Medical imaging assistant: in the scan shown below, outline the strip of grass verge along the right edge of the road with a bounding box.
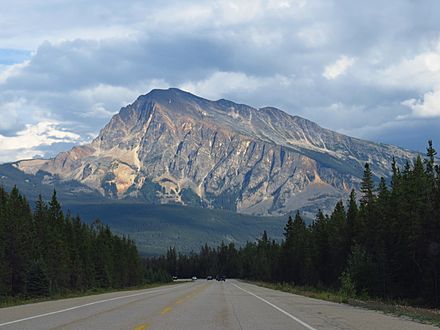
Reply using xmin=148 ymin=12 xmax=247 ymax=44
xmin=248 ymin=281 xmax=440 ymax=327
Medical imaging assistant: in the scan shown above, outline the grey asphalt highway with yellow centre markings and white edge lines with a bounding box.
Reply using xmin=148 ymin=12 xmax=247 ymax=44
xmin=0 ymin=280 xmax=438 ymax=330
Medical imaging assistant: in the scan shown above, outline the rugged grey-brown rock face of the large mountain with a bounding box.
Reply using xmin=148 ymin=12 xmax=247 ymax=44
xmin=14 ymin=89 xmax=415 ymax=215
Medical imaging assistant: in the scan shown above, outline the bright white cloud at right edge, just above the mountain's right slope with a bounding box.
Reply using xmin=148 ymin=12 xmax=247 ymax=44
xmin=400 ymin=88 xmax=440 ymax=118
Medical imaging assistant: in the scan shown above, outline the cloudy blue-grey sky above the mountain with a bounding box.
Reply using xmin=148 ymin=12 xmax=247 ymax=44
xmin=0 ymin=0 xmax=440 ymax=163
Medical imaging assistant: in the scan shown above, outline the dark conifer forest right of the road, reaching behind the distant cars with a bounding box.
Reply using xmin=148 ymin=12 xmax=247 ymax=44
xmin=146 ymin=141 xmax=440 ymax=307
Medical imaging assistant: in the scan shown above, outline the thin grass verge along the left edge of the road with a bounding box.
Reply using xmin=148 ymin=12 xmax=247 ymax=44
xmin=0 ymin=282 xmax=180 ymax=308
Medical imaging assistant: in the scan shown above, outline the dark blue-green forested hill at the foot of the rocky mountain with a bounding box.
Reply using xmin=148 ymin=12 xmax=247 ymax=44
xmin=64 ymin=201 xmax=287 ymax=255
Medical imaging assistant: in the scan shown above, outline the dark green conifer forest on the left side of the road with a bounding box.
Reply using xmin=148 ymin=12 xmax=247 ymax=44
xmin=0 ymin=188 xmax=143 ymax=300
